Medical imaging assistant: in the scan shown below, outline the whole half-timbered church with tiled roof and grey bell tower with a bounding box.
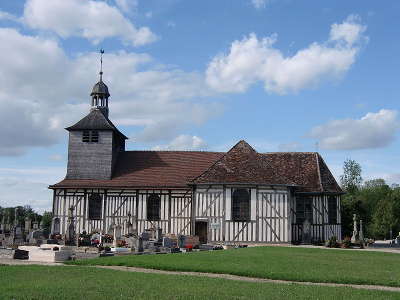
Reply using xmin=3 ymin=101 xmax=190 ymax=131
xmin=49 ymin=73 xmax=343 ymax=243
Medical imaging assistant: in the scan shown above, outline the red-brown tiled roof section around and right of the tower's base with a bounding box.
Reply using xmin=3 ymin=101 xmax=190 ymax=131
xmin=51 ymin=151 xmax=224 ymax=188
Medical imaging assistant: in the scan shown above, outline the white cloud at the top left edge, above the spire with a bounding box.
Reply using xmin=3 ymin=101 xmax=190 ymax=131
xmin=23 ymin=0 xmax=156 ymax=46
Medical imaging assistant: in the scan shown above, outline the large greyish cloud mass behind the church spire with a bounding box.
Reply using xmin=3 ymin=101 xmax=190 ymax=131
xmin=0 ymin=28 xmax=220 ymax=155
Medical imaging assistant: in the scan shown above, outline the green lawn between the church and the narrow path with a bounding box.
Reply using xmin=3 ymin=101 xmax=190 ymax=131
xmin=73 ymin=247 xmax=400 ymax=287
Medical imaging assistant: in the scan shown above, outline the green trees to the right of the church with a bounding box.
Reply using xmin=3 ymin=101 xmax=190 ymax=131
xmin=340 ymin=159 xmax=400 ymax=239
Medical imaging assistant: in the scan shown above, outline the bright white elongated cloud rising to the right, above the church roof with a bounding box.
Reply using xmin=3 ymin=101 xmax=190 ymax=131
xmin=206 ymin=16 xmax=366 ymax=94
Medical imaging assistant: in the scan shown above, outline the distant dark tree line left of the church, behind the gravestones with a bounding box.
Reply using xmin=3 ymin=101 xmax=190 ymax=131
xmin=0 ymin=205 xmax=52 ymax=231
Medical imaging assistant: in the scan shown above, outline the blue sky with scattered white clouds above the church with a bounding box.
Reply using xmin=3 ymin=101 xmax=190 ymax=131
xmin=0 ymin=0 xmax=400 ymax=210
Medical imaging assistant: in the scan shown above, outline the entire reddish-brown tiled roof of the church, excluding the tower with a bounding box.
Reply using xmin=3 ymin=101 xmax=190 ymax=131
xmin=50 ymin=141 xmax=342 ymax=193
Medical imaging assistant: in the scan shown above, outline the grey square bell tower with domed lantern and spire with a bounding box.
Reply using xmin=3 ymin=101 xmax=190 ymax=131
xmin=65 ymin=50 xmax=127 ymax=180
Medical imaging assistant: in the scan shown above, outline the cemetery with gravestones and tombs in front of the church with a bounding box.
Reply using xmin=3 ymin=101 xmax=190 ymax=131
xmin=0 ymin=209 xmax=230 ymax=262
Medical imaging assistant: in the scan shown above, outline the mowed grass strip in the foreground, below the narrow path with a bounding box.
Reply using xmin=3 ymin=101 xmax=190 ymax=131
xmin=0 ymin=266 xmax=400 ymax=300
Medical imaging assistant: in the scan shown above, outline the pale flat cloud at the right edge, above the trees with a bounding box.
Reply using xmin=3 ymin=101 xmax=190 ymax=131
xmin=309 ymin=109 xmax=400 ymax=150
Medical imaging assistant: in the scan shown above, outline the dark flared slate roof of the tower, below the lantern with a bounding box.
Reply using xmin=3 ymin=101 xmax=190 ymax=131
xmin=65 ymin=109 xmax=127 ymax=139
